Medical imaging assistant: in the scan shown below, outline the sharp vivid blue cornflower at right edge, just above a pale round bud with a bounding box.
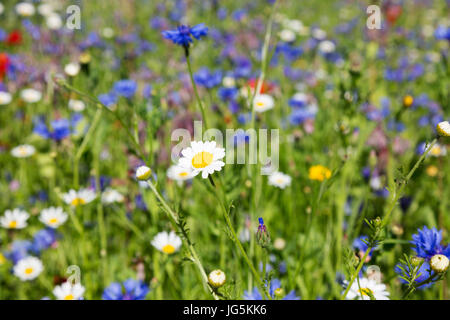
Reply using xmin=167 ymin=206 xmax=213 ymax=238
xmin=411 ymin=226 xmax=450 ymax=259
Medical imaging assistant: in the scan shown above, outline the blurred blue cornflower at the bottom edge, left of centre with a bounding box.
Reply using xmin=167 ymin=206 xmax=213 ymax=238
xmin=102 ymin=279 xmax=150 ymax=300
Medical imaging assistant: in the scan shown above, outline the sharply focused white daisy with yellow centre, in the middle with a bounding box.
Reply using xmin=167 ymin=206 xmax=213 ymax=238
xmin=178 ymin=141 xmax=225 ymax=179
